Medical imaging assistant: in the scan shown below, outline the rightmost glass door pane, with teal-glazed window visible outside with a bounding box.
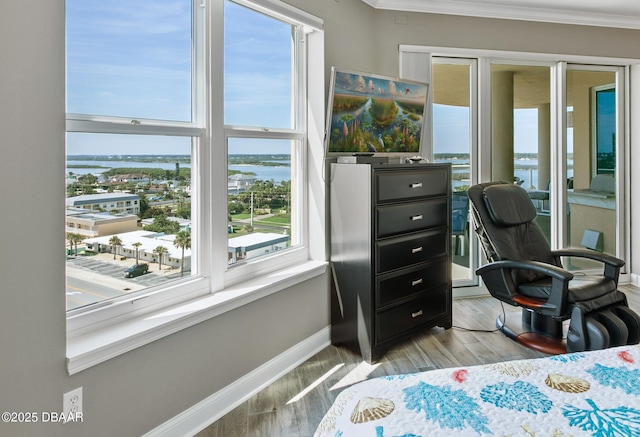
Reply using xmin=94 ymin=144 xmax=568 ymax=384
xmin=565 ymin=66 xmax=621 ymax=270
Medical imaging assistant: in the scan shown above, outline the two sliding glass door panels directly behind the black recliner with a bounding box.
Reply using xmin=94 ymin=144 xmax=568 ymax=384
xmin=488 ymin=62 xmax=624 ymax=270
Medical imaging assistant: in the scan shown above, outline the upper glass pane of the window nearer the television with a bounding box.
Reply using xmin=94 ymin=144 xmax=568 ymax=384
xmin=224 ymin=1 xmax=295 ymax=129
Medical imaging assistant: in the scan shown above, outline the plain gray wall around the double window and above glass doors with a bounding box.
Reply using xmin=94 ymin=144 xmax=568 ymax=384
xmin=0 ymin=0 xmax=640 ymax=437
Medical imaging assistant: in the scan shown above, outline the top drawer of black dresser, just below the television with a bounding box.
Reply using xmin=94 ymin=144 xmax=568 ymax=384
xmin=375 ymin=168 xmax=450 ymax=203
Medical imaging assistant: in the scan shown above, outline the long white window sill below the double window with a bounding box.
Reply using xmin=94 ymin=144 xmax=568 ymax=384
xmin=67 ymin=261 xmax=327 ymax=375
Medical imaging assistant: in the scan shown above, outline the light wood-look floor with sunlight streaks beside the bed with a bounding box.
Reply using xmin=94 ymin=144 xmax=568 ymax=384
xmin=196 ymin=285 xmax=640 ymax=437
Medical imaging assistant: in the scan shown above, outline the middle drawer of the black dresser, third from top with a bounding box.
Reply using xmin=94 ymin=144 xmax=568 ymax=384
xmin=375 ymin=229 xmax=449 ymax=273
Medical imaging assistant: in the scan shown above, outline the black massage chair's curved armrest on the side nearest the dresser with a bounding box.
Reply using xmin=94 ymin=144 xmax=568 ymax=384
xmin=476 ymin=260 xmax=573 ymax=317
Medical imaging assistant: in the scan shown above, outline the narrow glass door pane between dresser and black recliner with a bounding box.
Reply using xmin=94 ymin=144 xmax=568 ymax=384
xmin=431 ymin=58 xmax=475 ymax=285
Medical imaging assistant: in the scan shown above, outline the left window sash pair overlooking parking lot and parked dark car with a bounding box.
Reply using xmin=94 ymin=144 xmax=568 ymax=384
xmin=66 ymin=0 xmax=202 ymax=312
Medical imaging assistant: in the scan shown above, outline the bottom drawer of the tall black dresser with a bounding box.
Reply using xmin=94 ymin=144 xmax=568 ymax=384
xmin=376 ymin=288 xmax=449 ymax=343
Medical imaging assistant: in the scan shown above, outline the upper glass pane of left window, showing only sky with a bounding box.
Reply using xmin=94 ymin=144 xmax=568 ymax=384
xmin=66 ymin=0 xmax=192 ymax=121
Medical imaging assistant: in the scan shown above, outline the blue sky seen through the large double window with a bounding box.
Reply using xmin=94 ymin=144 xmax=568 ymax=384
xmin=66 ymin=0 xmax=292 ymax=155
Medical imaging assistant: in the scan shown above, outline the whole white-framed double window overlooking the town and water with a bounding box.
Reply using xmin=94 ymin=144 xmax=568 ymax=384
xmin=65 ymin=0 xmax=321 ymax=333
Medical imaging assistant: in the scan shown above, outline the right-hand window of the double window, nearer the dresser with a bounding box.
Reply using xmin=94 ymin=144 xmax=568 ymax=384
xmin=224 ymin=1 xmax=305 ymax=266
